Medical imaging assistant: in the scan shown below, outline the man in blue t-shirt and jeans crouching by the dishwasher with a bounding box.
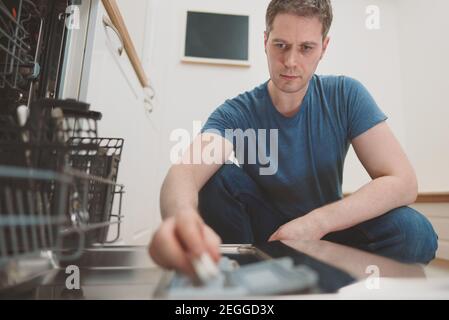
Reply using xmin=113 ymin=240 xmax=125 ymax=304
xmin=150 ymin=0 xmax=437 ymax=274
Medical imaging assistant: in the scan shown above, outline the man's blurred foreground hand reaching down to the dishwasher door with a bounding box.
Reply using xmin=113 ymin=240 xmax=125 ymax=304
xmin=149 ymin=212 xmax=221 ymax=277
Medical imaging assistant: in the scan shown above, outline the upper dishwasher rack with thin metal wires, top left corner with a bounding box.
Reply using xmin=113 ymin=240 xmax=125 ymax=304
xmin=0 ymin=0 xmax=74 ymax=114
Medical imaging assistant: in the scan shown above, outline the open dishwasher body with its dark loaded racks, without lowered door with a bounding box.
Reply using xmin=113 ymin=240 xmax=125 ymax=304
xmin=0 ymin=0 xmax=124 ymax=298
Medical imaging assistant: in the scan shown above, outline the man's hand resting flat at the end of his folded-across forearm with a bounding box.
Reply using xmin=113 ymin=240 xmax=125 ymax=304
xmin=268 ymin=212 xmax=327 ymax=241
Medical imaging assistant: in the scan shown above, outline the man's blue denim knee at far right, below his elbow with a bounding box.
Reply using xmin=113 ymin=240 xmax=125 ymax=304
xmin=360 ymin=207 xmax=438 ymax=263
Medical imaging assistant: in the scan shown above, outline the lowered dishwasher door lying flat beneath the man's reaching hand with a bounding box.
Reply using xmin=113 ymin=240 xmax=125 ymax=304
xmin=10 ymin=242 xmax=356 ymax=300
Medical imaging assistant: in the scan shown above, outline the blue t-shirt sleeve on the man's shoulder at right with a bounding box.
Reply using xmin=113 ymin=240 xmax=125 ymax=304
xmin=344 ymin=77 xmax=388 ymax=140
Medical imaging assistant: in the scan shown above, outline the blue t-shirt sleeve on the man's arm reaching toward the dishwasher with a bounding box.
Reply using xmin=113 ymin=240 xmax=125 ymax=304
xmin=201 ymin=100 xmax=241 ymax=143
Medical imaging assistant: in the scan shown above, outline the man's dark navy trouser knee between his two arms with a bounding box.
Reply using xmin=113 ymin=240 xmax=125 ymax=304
xmin=199 ymin=165 xmax=286 ymax=243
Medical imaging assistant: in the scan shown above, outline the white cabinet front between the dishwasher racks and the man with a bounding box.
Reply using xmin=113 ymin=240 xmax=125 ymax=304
xmin=74 ymin=0 xmax=160 ymax=244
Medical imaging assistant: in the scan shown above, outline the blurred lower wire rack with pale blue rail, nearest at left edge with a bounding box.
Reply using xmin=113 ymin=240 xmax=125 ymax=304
xmin=0 ymin=166 xmax=70 ymax=259
